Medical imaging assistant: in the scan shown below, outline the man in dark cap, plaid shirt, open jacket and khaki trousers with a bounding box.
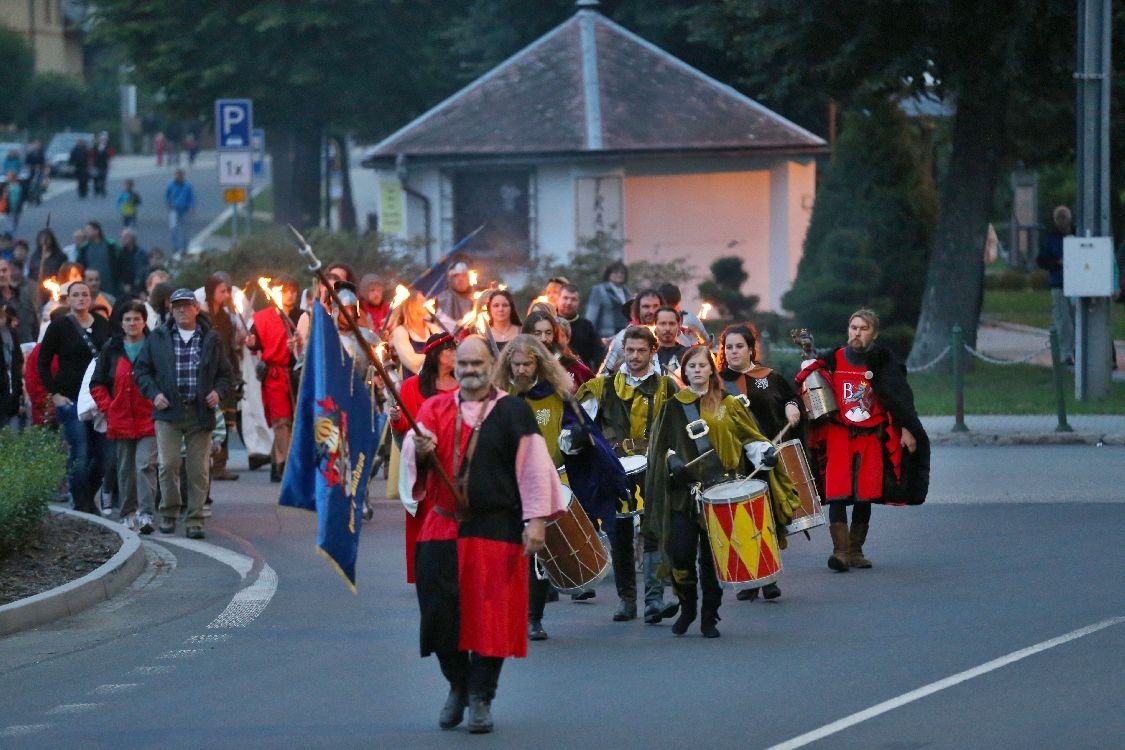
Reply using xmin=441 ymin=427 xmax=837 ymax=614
xmin=134 ymin=289 xmax=233 ymax=539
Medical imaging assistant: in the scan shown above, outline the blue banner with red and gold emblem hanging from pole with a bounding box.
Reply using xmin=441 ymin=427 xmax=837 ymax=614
xmin=280 ymin=305 xmax=386 ymax=591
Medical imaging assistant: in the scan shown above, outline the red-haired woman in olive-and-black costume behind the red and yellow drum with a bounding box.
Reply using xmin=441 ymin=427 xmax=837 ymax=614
xmin=645 ymin=345 xmax=798 ymax=638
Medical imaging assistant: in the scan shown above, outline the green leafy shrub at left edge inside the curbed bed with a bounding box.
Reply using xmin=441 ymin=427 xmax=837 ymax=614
xmin=0 ymin=427 xmax=66 ymax=558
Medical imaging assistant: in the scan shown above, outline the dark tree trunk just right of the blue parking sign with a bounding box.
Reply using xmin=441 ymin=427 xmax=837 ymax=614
xmin=271 ymin=124 xmax=321 ymax=229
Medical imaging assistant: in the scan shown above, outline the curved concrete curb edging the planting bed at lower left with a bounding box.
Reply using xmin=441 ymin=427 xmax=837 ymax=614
xmin=0 ymin=506 xmax=147 ymax=636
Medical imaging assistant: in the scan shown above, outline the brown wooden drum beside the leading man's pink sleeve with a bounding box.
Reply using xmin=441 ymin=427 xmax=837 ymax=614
xmin=536 ymin=485 xmax=610 ymax=594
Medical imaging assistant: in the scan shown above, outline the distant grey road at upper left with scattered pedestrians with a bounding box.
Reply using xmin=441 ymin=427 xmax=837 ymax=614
xmin=19 ymin=152 xmax=226 ymax=263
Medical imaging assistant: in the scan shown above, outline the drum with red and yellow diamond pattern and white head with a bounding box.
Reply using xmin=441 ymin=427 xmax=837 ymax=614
xmin=702 ymin=479 xmax=781 ymax=589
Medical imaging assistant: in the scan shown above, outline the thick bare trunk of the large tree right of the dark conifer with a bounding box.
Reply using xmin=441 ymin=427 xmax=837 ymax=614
xmin=909 ymin=85 xmax=1006 ymax=369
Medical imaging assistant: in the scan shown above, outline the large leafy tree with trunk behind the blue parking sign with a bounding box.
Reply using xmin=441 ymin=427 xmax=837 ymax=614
xmin=96 ymin=0 xmax=457 ymax=227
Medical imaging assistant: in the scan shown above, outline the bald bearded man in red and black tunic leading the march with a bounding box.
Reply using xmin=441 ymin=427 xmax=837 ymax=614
xmin=403 ymin=336 xmax=566 ymax=733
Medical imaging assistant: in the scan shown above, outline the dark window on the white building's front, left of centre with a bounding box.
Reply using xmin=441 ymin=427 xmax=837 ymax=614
xmin=452 ymin=170 xmax=534 ymax=261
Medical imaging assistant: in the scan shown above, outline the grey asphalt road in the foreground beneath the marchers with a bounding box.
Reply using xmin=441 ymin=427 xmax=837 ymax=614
xmin=0 ymin=446 xmax=1125 ymax=750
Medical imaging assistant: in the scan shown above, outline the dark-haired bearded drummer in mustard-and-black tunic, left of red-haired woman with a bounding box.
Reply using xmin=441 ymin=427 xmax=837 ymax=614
xmin=576 ymin=326 xmax=680 ymax=625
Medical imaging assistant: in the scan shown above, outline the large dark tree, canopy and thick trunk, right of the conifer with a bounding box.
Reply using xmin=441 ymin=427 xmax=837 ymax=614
xmin=694 ymin=0 xmax=1076 ymax=363
